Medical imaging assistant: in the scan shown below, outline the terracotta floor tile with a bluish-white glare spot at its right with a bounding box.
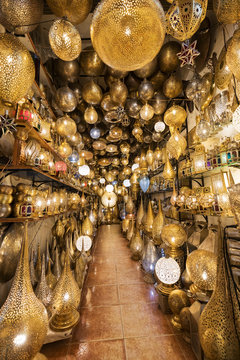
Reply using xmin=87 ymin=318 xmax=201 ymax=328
xmin=119 ymin=283 xmax=158 ymax=304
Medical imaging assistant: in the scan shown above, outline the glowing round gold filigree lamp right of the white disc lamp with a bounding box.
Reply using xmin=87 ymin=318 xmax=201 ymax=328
xmin=186 ymin=250 xmax=217 ymax=299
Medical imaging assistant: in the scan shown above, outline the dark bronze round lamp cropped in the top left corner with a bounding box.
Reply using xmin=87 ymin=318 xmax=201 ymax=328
xmin=0 ymin=0 xmax=43 ymax=34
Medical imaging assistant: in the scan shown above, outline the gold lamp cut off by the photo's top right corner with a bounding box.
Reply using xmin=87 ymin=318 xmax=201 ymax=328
xmin=213 ymin=0 xmax=240 ymax=24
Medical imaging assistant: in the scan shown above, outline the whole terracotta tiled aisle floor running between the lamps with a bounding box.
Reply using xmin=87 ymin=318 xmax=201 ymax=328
xmin=42 ymin=225 xmax=196 ymax=360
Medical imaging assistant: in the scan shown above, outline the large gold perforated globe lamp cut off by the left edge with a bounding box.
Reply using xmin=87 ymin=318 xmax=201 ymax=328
xmin=0 ymin=34 xmax=35 ymax=103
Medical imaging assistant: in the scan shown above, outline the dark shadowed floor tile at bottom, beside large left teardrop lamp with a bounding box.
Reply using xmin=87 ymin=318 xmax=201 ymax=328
xmin=41 ymin=339 xmax=71 ymax=360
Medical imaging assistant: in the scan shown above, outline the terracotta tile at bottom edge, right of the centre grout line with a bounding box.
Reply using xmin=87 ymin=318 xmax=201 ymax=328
xmin=125 ymin=336 xmax=185 ymax=360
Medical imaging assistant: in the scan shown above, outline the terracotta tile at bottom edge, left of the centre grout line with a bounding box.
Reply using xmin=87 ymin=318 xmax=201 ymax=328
xmin=69 ymin=340 xmax=126 ymax=360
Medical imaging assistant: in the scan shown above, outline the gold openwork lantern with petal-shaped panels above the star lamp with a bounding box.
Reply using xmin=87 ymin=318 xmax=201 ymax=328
xmin=166 ymin=0 xmax=208 ymax=41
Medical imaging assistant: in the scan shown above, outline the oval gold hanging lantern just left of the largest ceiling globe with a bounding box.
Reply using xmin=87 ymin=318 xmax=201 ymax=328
xmin=49 ymin=19 xmax=82 ymax=61
